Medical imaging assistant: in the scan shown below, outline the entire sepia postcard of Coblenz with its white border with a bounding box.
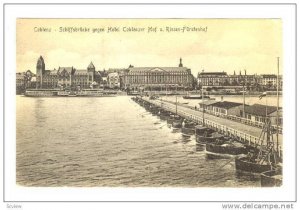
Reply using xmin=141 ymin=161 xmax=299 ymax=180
xmin=5 ymin=2 xmax=294 ymax=207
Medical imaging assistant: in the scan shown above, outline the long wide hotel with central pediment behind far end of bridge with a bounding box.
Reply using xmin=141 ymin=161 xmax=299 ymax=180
xmin=122 ymin=58 xmax=194 ymax=90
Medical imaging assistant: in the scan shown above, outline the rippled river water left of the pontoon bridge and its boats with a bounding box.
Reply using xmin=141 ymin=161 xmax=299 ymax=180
xmin=16 ymin=96 xmax=260 ymax=187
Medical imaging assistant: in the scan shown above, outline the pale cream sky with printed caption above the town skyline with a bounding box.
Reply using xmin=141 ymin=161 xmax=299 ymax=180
xmin=16 ymin=19 xmax=282 ymax=76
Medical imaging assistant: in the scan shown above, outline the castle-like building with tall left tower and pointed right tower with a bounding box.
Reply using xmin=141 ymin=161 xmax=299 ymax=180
xmin=36 ymin=56 xmax=101 ymax=88
